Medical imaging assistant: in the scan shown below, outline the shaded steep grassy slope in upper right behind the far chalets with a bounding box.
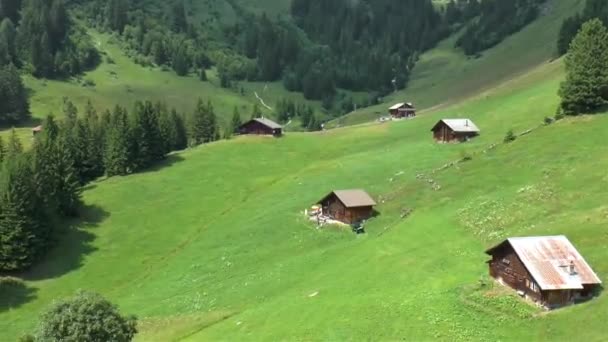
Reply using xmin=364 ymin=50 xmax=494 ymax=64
xmin=333 ymin=0 xmax=585 ymax=125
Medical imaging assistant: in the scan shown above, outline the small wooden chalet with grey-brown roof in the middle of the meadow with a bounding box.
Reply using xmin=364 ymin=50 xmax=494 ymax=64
xmin=318 ymin=190 xmax=376 ymax=224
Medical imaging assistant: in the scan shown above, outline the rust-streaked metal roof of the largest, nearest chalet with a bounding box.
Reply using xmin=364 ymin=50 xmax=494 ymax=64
xmin=488 ymin=235 xmax=602 ymax=290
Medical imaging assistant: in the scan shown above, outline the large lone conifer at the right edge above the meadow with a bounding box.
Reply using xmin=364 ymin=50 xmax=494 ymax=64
xmin=559 ymin=19 xmax=608 ymax=115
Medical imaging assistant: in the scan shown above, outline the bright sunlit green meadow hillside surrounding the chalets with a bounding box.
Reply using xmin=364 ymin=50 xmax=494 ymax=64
xmin=0 ymin=50 xmax=608 ymax=341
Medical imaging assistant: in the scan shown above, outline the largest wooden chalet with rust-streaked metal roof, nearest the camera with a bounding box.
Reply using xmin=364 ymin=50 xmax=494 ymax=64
xmin=486 ymin=236 xmax=602 ymax=309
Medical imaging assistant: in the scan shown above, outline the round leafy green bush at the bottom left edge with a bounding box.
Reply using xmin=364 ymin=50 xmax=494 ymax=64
xmin=35 ymin=291 xmax=137 ymax=342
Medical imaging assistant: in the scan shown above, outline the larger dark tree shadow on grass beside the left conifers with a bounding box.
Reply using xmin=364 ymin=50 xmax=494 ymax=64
xmin=19 ymin=206 xmax=110 ymax=281
